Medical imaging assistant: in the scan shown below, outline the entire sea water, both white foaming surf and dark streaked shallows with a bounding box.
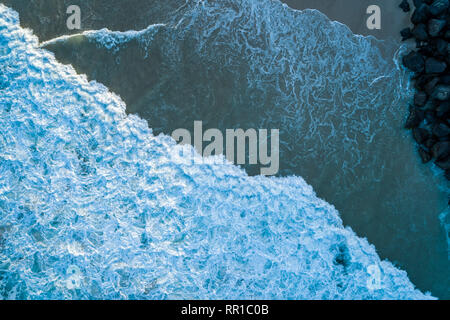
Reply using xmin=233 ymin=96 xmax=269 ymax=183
xmin=1 ymin=0 xmax=450 ymax=298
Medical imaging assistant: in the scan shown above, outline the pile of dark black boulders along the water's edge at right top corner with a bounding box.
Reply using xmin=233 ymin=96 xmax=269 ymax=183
xmin=400 ymin=0 xmax=450 ymax=180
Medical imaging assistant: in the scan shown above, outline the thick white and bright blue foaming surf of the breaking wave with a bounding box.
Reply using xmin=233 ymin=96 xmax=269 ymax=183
xmin=0 ymin=5 xmax=431 ymax=299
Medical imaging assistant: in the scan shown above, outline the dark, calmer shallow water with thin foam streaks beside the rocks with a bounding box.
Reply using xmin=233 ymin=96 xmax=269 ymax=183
xmin=27 ymin=0 xmax=450 ymax=298
